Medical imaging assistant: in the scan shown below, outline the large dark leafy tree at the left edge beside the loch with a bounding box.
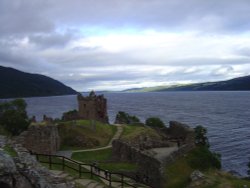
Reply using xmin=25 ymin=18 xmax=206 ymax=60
xmin=0 ymin=99 xmax=30 ymax=135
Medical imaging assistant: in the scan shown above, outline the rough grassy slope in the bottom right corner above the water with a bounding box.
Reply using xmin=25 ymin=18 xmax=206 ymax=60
xmin=163 ymin=148 xmax=250 ymax=188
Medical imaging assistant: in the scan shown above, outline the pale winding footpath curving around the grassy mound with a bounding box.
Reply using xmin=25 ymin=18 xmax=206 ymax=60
xmin=56 ymin=124 xmax=123 ymax=158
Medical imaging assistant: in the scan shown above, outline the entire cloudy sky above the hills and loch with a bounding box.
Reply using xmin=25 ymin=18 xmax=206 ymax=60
xmin=0 ymin=0 xmax=250 ymax=91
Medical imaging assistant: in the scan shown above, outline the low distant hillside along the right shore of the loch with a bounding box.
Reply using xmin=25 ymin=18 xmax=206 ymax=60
xmin=125 ymin=76 xmax=250 ymax=92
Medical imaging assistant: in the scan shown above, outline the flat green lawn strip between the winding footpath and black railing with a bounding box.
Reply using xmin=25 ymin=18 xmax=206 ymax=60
xmin=71 ymin=148 xmax=112 ymax=163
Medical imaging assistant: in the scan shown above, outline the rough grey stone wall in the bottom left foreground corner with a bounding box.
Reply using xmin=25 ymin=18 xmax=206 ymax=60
xmin=0 ymin=136 xmax=75 ymax=188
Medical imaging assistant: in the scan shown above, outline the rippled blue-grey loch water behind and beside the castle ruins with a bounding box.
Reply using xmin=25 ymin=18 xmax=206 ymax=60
xmin=25 ymin=91 xmax=250 ymax=176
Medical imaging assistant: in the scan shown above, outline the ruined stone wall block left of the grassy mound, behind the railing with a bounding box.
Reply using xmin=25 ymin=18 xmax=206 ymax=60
xmin=19 ymin=125 xmax=60 ymax=154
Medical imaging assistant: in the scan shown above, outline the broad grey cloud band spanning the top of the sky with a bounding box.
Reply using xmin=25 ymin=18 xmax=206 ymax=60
xmin=0 ymin=0 xmax=250 ymax=35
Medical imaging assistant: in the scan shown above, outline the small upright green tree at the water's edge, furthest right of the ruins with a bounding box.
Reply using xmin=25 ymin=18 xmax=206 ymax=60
xmin=194 ymin=125 xmax=209 ymax=147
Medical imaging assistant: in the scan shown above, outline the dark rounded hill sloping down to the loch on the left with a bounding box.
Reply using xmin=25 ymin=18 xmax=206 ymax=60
xmin=0 ymin=66 xmax=76 ymax=98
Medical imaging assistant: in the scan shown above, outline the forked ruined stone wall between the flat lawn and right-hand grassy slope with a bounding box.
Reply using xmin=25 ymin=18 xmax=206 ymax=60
xmin=112 ymin=134 xmax=195 ymax=188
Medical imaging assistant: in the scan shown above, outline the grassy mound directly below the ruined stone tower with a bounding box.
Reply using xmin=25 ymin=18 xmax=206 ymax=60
xmin=58 ymin=120 xmax=117 ymax=150
